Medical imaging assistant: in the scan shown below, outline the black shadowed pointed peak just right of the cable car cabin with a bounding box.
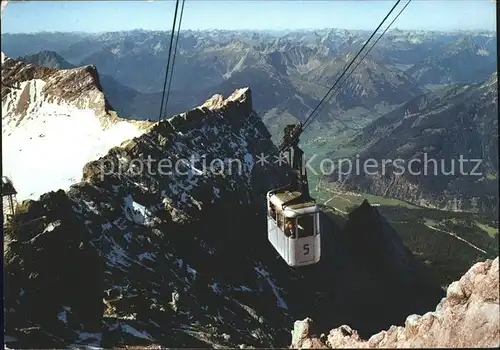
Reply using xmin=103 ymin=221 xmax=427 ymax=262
xmin=302 ymin=200 xmax=444 ymax=337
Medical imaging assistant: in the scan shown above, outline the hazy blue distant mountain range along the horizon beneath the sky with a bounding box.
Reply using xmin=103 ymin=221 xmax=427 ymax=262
xmin=1 ymin=29 xmax=496 ymax=130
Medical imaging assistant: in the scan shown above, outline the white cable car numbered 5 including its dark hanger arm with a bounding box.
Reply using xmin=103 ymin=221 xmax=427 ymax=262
xmin=267 ymin=123 xmax=321 ymax=267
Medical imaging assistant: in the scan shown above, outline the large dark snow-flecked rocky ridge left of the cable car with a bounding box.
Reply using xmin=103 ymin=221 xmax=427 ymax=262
xmin=5 ymin=84 xmax=292 ymax=347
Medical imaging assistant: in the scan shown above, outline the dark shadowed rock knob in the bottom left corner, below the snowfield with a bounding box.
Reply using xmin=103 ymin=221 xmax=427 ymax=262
xmin=4 ymin=190 xmax=104 ymax=348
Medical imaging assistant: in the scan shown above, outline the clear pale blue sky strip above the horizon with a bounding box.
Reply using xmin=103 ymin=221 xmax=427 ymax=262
xmin=2 ymin=0 xmax=496 ymax=33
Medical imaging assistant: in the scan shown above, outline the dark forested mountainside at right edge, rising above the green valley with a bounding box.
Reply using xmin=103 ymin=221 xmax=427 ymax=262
xmin=331 ymin=73 xmax=498 ymax=214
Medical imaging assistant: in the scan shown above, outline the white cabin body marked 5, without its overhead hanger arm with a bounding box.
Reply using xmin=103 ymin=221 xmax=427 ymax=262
xmin=267 ymin=192 xmax=321 ymax=267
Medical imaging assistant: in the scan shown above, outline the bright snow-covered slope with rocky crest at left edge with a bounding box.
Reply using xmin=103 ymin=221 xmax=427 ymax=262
xmin=1 ymin=51 xmax=150 ymax=200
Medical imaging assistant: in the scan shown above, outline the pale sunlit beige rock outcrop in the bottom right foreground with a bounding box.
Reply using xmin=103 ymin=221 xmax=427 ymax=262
xmin=291 ymin=257 xmax=500 ymax=348
